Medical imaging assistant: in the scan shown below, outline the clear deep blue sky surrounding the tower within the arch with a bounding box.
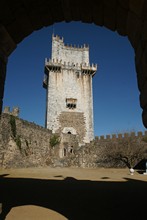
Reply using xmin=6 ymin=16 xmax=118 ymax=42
xmin=3 ymin=22 xmax=146 ymax=136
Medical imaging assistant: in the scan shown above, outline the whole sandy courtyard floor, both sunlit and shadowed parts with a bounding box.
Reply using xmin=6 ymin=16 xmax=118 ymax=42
xmin=0 ymin=168 xmax=147 ymax=220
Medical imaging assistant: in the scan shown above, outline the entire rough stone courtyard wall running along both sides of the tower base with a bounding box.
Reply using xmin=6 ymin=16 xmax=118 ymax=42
xmin=0 ymin=113 xmax=147 ymax=168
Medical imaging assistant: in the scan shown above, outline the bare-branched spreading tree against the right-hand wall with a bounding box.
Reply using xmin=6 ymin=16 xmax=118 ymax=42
xmin=99 ymin=135 xmax=147 ymax=169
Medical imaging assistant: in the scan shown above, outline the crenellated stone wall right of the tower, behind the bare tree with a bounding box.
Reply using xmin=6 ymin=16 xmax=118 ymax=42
xmin=56 ymin=132 xmax=147 ymax=168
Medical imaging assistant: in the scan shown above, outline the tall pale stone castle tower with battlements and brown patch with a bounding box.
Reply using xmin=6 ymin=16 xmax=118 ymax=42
xmin=43 ymin=36 xmax=97 ymax=144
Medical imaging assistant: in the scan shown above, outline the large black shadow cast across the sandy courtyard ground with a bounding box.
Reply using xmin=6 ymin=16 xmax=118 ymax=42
xmin=0 ymin=175 xmax=147 ymax=220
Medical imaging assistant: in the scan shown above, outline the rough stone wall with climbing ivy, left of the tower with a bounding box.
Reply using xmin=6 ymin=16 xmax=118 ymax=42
xmin=0 ymin=113 xmax=51 ymax=167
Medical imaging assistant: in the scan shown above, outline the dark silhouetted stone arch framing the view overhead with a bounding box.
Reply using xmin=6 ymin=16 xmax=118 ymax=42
xmin=0 ymin=0 xmax=147 ymax=128
